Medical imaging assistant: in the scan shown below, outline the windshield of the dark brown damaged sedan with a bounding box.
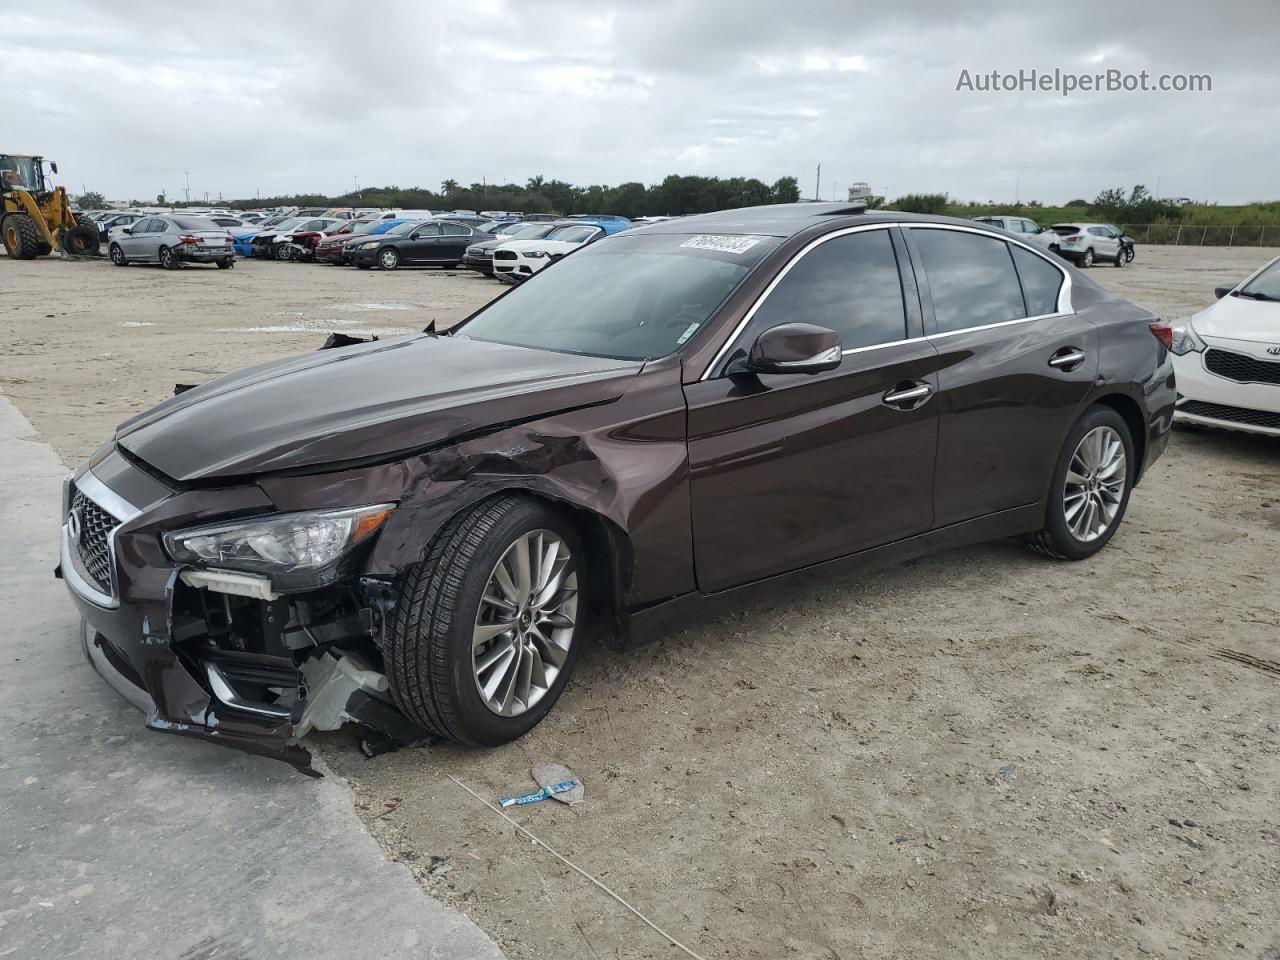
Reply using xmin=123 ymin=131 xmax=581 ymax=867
xmin=458 ymin=234 xmax=780 ymax=360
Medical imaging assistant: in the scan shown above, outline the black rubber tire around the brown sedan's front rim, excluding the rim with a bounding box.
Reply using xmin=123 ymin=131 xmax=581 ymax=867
xmin=384 ymin=494 xmax=590 ymax=746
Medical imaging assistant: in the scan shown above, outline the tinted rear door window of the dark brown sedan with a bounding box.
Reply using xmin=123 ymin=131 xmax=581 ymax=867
xmin=911 ymin=229 xmax=1027 ymax=333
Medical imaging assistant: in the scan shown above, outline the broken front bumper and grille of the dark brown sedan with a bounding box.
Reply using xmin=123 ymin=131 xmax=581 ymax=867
xmin=58 ymin=451 xmax=428 ymax=776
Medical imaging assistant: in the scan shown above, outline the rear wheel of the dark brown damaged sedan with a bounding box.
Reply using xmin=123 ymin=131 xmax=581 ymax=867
xmin=1027 ymin=406 xmax=1137 ymax=559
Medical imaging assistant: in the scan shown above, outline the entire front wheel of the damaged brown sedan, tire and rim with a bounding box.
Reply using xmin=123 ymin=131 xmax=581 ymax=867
xmin=385 ymin=494 xmax=589 ymax=746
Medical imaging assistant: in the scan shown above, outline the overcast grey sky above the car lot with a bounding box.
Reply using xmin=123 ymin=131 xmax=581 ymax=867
xmin=0 ymin=0 xmax=1280 ymax=204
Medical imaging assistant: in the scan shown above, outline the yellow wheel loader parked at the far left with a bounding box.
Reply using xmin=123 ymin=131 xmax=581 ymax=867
xmin=0 ymin=152 xmax=99 ymax=260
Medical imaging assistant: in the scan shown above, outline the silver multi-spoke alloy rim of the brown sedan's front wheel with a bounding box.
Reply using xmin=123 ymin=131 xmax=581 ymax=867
xmin=471 ymin=530 xmax=577 ymax=717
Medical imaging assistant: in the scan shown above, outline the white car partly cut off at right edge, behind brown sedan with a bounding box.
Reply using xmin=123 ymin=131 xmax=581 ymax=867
xmin=1166 ymin=257 xmax=1280 ymax=436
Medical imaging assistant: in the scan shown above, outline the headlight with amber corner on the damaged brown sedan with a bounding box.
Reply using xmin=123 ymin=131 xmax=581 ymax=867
xmin=164 ymin=503 xmax=396 ymax=573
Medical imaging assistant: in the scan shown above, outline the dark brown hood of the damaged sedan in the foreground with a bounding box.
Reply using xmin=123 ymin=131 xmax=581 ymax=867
xmin=115 ymin=335 xmax=643 ymax=483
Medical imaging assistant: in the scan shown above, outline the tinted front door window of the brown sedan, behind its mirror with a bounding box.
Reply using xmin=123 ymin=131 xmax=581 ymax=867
xmin=750 ymin=230 xmax=906 ymax=349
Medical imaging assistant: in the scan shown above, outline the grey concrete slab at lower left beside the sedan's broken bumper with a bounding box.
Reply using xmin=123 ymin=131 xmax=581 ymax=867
xmin=0 ymin=397 xmax=502 ymax=960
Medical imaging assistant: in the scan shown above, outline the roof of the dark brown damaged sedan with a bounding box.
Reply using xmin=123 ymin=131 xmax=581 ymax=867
xmin=627 ymin=202 xmax=1004 ymax=238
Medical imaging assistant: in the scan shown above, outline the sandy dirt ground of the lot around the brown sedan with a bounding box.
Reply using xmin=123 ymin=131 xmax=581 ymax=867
xmin=0 ymin=247 xmax=1280 ymax=960
